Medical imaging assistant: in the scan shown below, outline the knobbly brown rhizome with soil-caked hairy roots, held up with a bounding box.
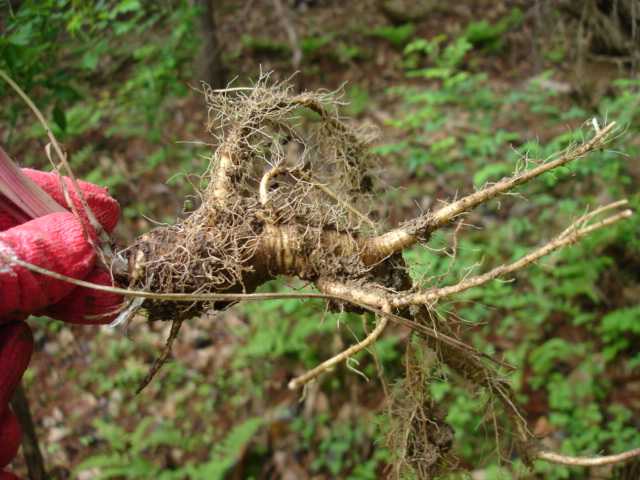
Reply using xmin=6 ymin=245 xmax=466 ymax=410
xmin=116 ymin=78 xmax=629 ymax=478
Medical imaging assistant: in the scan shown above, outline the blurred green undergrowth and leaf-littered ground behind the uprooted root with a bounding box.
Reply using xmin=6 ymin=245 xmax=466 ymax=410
xmin=0 ymin=0 xmax=640 ymax=480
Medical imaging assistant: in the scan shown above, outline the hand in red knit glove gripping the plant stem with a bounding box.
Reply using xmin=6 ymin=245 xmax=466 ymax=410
xmin=0 ymin=170 xmax=122 ymax=472
